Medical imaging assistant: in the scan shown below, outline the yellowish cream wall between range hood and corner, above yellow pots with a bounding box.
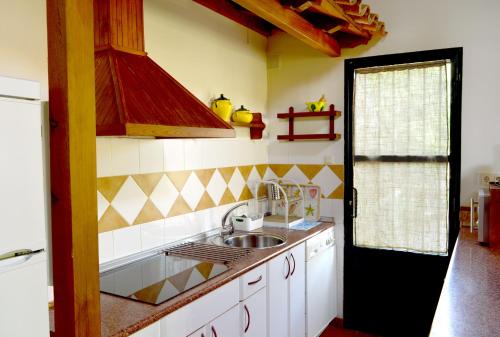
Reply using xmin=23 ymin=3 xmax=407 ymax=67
xmin=144 ymin=0 xmax=267 ymax=116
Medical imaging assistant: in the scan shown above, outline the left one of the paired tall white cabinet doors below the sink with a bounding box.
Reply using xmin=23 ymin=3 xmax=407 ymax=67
xmin=267 ymin=252 xmax=291 ymax=337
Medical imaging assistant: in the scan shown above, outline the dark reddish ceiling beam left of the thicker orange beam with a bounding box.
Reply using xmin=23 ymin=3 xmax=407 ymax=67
xmin=194 ymin=0 xmax=274 ymax=37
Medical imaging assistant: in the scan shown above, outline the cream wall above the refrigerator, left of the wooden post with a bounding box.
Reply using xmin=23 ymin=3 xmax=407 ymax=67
xmin=0 ymin=0 xmax=48 ymax=100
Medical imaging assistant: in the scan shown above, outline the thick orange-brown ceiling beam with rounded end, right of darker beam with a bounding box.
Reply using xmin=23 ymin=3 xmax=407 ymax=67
xmin=233 ymin=0 xmax=340 ymax=56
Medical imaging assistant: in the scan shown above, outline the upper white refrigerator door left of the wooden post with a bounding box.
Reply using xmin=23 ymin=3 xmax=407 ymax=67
xmin=0 ymin=98 xmax=46 ymax=253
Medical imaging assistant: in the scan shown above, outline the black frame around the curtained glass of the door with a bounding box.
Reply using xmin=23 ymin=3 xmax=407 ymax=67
xmin=344 ymin=48 xmax=463 ymax=334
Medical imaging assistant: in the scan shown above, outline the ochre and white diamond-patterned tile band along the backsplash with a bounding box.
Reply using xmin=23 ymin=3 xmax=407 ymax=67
xmin=97 ymin=164 xmax=344 ymax=233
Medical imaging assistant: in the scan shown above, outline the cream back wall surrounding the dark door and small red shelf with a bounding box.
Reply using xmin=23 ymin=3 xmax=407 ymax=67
xmin=268 ymin=0 xmax=500 ymax=318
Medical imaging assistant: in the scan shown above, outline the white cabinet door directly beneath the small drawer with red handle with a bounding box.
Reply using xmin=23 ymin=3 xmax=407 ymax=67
xmin=241 ymin=288 xmax=267 ymax=337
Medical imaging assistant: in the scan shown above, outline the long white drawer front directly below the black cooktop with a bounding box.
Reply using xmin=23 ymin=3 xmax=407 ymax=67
xmin=161 ymin=279 xmax=239 ymax=337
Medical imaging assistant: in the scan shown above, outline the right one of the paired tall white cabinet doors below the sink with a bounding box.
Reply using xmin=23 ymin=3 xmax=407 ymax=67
xmin=289 ymin=243 xmax=306 ymax=337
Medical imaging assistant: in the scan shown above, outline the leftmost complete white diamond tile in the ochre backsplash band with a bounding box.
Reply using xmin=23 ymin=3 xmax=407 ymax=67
xmin=111 ymin=177 xmax=148 ymax=225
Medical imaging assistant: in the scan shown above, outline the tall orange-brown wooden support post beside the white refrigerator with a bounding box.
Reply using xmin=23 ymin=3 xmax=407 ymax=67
xmin=47 ymin=0 xmax=101 ymax=337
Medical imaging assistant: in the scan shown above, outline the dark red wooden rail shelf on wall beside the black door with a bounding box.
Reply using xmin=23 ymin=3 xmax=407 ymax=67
xmin=277 ymin=104 xmax=342 ymax=142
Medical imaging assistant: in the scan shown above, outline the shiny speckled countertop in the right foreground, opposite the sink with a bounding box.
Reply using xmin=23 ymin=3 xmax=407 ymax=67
xmin=429 ymin=229 xmax=500 ymax=337
